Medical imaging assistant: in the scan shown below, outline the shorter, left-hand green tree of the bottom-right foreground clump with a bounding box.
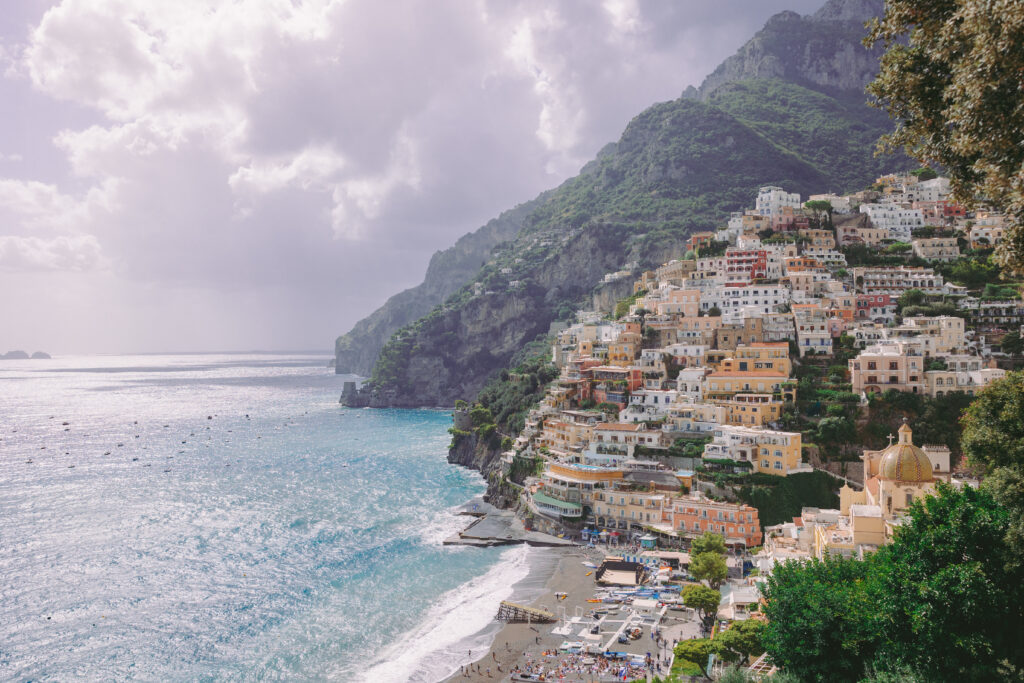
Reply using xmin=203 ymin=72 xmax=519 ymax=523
xmin=762 ymin=556 xmax=882 ymax=681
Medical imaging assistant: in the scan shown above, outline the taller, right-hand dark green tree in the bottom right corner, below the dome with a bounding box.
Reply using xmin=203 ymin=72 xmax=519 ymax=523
xmin=879 ymin=483 xmax=1024 ymax=681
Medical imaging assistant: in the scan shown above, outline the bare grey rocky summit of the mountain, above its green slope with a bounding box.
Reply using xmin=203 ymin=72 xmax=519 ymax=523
xmin=685 ymin=0 xmax=884 ymax=99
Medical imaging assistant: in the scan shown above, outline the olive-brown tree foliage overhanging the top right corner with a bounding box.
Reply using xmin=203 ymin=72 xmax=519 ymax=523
xmin=864 ymin=0 xmax=1024 ymax=270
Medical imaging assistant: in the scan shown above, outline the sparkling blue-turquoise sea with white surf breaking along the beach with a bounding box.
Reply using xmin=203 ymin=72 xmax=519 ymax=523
xmin=0 ymin=354 xmax=536 ymax=681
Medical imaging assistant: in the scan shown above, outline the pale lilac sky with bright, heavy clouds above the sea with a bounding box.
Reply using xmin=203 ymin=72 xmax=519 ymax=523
xmin=0 ymin=0 xmax=822 ymax=353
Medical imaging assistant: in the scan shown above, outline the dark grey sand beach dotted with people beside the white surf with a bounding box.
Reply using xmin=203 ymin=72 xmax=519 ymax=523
xmin=446 ymin=548 xmax=695 ymax=683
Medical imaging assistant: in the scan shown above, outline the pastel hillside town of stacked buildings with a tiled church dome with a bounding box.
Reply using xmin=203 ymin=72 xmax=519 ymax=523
xmin=453 ymin=174 xmax=1024 ymax=679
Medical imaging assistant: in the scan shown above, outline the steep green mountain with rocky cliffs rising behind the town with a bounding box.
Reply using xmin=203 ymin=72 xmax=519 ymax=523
xmin=335 ymin=0 xmax=894 ymax=407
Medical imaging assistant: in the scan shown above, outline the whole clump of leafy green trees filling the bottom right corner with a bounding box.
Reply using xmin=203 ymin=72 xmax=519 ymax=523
xmin=762 ymin=483 xmax=1024 ymax=681
